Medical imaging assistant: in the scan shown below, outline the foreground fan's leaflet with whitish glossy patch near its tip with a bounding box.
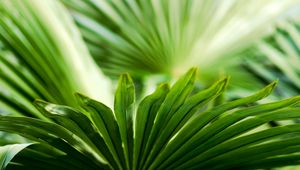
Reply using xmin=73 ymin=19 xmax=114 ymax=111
xmin=35 ymin=101 xmax=116 ymax=167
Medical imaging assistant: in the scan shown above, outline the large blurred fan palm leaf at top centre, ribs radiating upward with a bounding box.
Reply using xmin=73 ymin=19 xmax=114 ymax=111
xmin=62 ymin=0 xmax=296 ymax=77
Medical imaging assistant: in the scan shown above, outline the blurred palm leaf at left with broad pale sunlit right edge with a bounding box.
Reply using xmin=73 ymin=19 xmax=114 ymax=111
xmin=0 ymin=0 xmax=112 ymax=118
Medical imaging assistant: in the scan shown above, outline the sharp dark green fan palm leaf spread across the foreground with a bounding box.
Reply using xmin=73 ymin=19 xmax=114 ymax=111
xmin=0 ymin=69 xmax=300 ymax=169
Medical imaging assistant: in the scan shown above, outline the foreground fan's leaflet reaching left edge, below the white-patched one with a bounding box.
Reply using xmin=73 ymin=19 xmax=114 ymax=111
xmin=0 ymin=116 xmax=107 ymax=168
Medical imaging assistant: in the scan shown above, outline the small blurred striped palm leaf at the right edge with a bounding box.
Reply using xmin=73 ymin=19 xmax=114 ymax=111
xmin=244 ymin=18 xmax=300 ymax=97
